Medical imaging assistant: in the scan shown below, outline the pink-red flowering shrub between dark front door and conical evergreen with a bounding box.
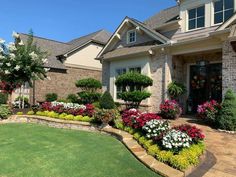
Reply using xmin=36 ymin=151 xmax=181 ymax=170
xmin=197 ymin=100 xmax=221 ymax=123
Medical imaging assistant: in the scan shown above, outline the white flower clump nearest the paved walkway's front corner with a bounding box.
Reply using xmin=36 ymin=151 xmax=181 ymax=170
xmin=162 ymin=129 xmax=192 ymax=152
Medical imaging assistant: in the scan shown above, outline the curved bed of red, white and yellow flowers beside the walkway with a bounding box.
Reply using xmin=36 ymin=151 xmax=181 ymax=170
xmin=116 ymin=109 xmax=205 ymax=170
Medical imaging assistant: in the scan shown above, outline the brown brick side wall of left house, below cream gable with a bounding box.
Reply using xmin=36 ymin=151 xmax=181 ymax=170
xmin=30 ymin=67 xmax=102 ymax=103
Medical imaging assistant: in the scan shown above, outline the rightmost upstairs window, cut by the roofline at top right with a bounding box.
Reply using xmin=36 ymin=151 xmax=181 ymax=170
xmin=214 ymin=0 xmax=234 ymax=24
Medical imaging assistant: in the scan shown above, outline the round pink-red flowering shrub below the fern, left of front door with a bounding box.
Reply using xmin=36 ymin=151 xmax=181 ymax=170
xmin=160 ymin=100 xmax=182 ymax=119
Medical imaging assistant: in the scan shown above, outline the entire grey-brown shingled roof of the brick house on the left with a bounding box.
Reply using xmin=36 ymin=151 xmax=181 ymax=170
xmin=20 ymin=30 xmax=111 ymax=69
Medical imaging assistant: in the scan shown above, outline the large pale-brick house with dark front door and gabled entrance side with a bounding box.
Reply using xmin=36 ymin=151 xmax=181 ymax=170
xmin=97 ymin=0 xmax=236 ymax=111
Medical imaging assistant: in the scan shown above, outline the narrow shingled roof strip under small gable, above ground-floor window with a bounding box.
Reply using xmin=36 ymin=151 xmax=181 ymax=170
xmin=103 ymin=45 xmax=155 ymax=59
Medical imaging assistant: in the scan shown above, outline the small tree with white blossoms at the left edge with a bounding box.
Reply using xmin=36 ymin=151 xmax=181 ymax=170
xmin=0 ymin=32 xmax=48 ymax=104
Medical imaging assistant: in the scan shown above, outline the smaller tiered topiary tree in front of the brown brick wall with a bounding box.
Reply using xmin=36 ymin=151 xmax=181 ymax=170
xmin=75 ymin=78 xmax=102 ymax=104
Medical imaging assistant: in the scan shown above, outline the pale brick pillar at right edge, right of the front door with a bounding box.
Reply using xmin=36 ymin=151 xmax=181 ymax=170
xmin=222 ymin=41 xmax=236 ymax=94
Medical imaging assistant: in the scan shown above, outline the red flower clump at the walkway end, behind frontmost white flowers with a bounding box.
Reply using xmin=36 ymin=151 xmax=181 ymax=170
xmin=174 ymin=124 xmax=205 ymax=143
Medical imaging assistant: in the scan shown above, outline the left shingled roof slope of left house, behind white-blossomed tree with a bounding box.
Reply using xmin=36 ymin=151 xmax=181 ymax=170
xmin=20 ymin=33 xmax=70 ymax=69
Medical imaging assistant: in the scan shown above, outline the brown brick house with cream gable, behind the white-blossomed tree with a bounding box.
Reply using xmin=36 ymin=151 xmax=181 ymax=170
xmin=14 ymin=30 xmax=111 ymax=103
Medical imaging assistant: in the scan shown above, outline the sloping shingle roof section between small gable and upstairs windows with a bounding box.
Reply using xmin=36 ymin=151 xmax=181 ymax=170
xmin=144 ymin=6 xmax=179 ymax=29
